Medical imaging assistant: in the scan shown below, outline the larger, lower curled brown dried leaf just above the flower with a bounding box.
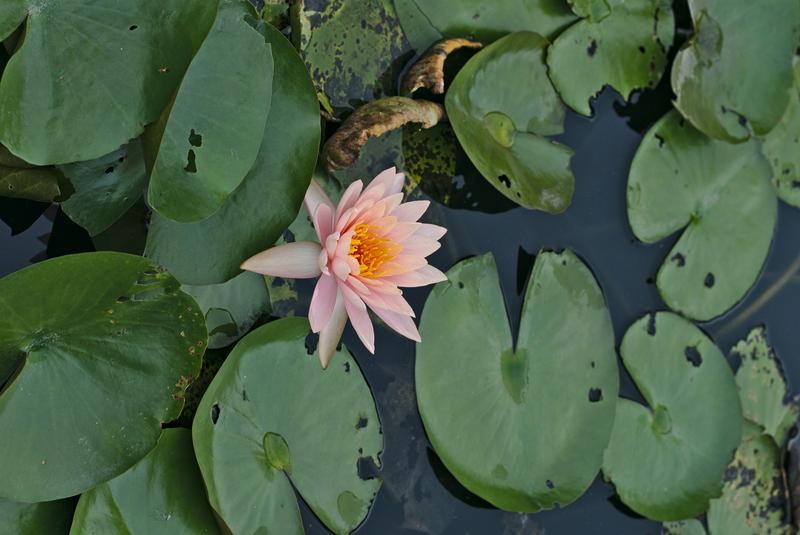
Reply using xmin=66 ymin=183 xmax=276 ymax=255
xmin=322 ymin=97 xmax=444 ymax=173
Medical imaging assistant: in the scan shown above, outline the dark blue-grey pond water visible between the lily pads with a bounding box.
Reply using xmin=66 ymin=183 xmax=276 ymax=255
xmin=0 ymin=91 xmax=800 ymax=535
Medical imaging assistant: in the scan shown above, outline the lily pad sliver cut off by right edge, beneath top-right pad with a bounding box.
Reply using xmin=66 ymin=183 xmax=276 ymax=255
xmin=762 ymin=59 xmax=800 ymax=208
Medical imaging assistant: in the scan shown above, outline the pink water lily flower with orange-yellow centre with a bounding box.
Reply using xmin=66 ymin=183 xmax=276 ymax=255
xmin=242 ymin=168 xmax=447 ymax=368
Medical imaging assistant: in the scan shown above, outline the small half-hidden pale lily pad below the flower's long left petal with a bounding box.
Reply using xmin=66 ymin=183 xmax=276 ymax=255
xmin=183 ymin=272 xmax=269 ymax=348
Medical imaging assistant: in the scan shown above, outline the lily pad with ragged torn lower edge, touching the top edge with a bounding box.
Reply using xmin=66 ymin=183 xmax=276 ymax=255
xmin=547 ymin=0 xmax=675 ymax=116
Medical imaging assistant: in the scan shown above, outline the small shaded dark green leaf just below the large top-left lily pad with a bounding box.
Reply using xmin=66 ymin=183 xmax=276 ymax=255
xmin=60 ymin=140 xmax=147 ymax=236
